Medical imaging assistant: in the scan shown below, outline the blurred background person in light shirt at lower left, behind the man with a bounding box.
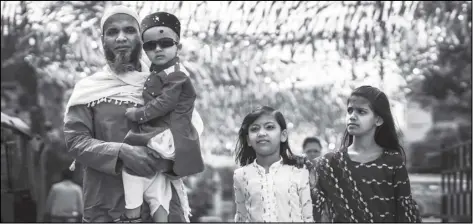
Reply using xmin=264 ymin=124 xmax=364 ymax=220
xmin=45 ymin=169 xmax=84 ymax=222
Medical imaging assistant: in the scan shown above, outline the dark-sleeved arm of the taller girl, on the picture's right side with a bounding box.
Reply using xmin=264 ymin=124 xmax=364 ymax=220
xmin=394 ymin=160 xmax=422 ymax=222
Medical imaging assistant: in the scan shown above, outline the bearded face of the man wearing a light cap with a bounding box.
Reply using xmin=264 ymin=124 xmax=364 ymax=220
xmin=102 ymin=13 xmax=141 ymax=73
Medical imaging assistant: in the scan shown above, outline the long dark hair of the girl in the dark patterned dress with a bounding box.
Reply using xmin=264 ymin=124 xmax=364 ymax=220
xmin=341 ymin=86 xmax=406 ymax=161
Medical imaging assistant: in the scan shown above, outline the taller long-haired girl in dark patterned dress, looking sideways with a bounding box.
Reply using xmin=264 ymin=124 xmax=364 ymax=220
xmin=313 ymin=86 xmax=421 ymax=222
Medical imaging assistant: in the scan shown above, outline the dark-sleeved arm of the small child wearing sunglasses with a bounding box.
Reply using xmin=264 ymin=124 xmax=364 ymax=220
xmin=134 ymin=71 xmax=189 ymax=124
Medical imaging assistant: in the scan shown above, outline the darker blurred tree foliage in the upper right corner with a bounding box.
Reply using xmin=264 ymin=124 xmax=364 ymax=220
xmin=399 ymin=1 xmax=472 ymax=122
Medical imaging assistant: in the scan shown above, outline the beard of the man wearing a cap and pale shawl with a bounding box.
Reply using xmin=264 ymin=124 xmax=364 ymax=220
xmin=103 ymin=44 xmax=141 ymax=74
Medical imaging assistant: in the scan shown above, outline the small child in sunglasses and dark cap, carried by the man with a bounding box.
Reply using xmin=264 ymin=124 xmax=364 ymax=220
xmin=120 ymin=12 xmax=204 ymax=222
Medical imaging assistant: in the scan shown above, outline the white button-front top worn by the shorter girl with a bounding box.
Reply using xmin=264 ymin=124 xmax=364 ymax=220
xmin=233 ymin=159 xmax=313 ymax=222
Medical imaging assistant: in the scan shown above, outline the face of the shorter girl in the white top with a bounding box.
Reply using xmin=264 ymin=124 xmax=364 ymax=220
xmin=248 ymin=114 xmax=287 ymax=156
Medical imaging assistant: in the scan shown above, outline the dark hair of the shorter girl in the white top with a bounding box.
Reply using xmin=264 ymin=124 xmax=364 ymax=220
xmin=235 ymin=106 xmax=296 ymax=166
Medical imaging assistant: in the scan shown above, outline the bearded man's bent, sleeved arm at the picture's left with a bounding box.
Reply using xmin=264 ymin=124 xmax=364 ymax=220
xmin=64 ymin=105 xmax=123 ymax=175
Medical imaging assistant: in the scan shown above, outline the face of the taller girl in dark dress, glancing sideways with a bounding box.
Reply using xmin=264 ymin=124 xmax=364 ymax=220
xmin=346 ymin=96 xmax=383 ymax=136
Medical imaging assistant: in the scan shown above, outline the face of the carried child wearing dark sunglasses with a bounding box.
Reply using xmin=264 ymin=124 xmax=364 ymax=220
xmin=143 ymin=26 xmax=181 ymax=65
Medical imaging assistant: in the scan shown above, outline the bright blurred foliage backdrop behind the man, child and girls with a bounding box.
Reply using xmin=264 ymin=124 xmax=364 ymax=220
xmin=6 ymin=1 xmax=468 ymax=151
